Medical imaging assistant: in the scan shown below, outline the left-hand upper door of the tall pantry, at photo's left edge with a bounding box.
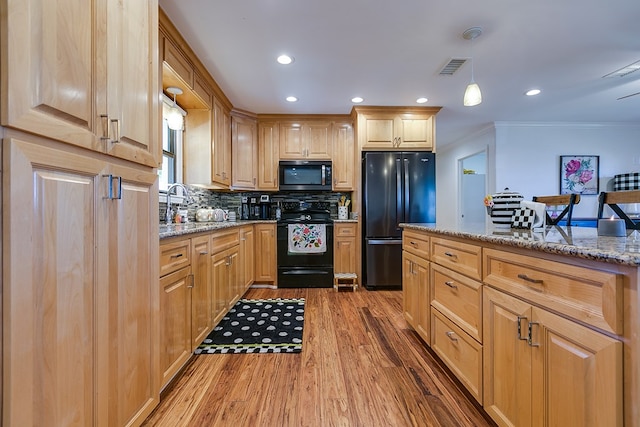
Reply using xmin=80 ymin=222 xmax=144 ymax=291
xmin=1 ymin=0 xmax=101 ymax=150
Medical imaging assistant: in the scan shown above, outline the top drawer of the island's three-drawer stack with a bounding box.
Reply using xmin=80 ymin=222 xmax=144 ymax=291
xmin=431 ymin=237 xmax=482 ymax=280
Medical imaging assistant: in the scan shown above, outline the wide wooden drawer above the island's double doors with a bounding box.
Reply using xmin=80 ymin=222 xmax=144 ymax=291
xmin=484 ymin=249 xmax=623 ymax=334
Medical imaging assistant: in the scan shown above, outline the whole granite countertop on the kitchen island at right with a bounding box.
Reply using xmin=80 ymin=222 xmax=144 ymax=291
xmin=400 ymin=223 xmax=640 ymax=267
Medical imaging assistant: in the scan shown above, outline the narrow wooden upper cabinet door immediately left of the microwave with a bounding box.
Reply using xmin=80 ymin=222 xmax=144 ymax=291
xmin=258 ymin=121 xmax=280 ymax=191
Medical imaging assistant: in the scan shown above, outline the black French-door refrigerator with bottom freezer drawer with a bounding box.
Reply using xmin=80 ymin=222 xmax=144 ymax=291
xmin=362 ymin=151 xmax=436 ymax=290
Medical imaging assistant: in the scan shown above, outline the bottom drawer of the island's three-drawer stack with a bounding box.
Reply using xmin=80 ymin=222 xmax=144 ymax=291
xmin=431 ymin=309 xmax=482 ymax=403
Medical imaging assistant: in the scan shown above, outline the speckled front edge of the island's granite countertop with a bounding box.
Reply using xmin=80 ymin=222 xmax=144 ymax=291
xmin=400 ymin=223 xmax=640 ymax=267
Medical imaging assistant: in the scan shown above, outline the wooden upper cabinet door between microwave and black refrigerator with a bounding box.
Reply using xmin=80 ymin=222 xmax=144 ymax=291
xmin=332 ymin=122 xmax=356 ymax=192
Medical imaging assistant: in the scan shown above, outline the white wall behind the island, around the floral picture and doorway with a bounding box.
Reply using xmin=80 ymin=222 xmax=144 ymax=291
xmin=436 ymin=122 xmax=640 ymax=226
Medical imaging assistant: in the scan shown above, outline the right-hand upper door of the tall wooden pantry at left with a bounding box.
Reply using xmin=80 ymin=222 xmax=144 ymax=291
xmin=104 ymin=0 xmax=161 ymax=167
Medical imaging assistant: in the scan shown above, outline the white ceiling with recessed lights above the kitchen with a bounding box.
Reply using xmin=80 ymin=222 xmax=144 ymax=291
xmin=160 ymin=0 xmax=640 ymax=147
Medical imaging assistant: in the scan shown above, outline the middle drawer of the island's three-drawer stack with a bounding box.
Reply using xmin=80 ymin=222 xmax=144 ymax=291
xmin=430 ymin=264 xmax=482 ymax=342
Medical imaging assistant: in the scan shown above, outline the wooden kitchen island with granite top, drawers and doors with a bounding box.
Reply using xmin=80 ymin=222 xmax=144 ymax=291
xmin=401 ymin=224 xmax=640 ymax=426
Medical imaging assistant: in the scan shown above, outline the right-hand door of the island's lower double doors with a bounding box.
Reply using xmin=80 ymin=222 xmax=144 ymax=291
xmin=531 ymin=308 xmax=623 ymax=427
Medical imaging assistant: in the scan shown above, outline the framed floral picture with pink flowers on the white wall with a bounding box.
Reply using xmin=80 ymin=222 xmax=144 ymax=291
xmin=560 ymin=156 xmax=600 ymax=195
